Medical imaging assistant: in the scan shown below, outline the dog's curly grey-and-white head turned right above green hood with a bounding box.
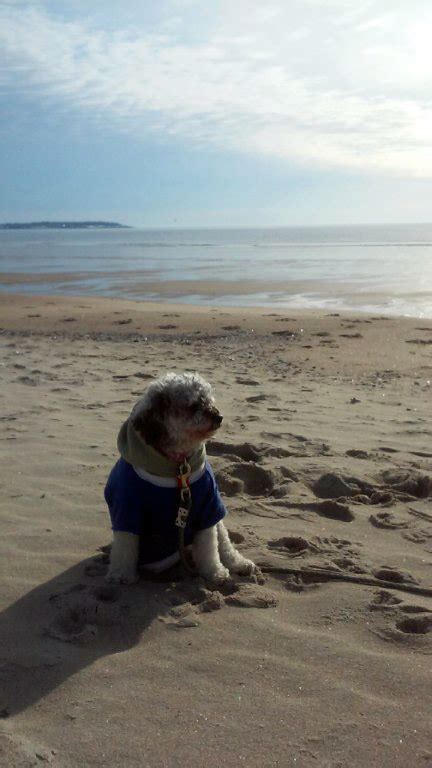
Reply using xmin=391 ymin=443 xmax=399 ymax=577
xmin=131 ymin=373 xmax=222 ymax=461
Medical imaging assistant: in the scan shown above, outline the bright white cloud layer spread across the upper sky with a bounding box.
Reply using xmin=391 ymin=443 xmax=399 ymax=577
xmin=0 ymin=0 xmax=432 ymax=178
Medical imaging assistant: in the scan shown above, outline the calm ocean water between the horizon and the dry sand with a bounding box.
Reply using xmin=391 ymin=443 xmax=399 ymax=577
xmin=0 ymin=224 xmax=432 ymax=318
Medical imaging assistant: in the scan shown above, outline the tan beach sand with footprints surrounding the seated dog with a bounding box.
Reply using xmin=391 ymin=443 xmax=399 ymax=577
xmin=0 ymin=294 xmax=432 ymax=768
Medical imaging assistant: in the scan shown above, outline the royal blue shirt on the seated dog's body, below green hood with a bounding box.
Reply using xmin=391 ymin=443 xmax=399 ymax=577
xmin=105 ymin=459 xmax=226 ymax=565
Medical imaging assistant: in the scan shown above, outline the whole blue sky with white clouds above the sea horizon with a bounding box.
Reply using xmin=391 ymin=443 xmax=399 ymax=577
xmin=0 ymin=0 xmax=432 ymax=227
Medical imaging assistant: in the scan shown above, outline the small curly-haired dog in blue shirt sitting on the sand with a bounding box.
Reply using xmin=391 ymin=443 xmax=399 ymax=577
xmin=105 ymin=373 xmax=259 ymax=584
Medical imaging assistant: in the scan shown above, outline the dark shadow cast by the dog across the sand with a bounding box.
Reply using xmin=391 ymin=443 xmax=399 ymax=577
xmin=0 ymin=553 xmax=201 ymax=718
